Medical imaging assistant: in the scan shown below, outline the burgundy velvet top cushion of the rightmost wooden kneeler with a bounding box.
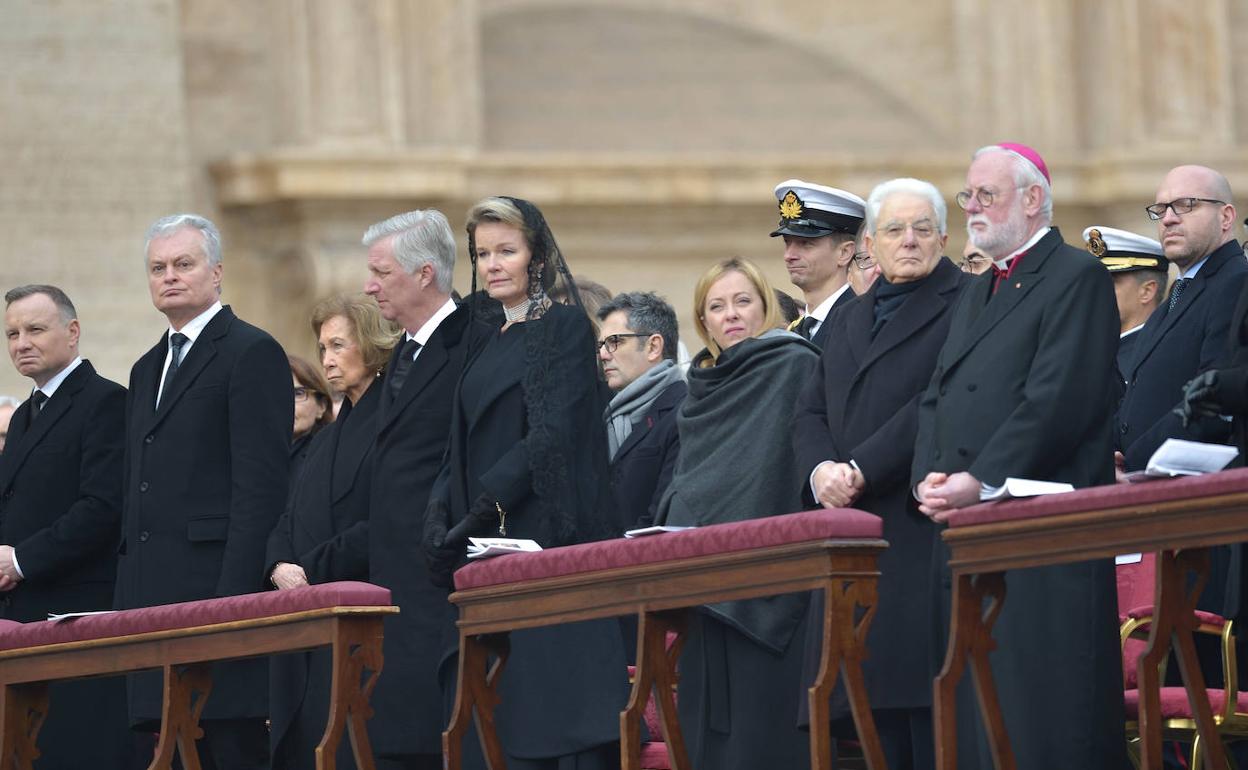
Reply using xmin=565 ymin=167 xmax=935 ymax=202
xmin=946 ymin=468 xmax=1248 ymax=527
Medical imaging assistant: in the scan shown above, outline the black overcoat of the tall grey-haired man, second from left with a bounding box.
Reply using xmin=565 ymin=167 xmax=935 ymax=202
xmin=117 ymin=306 xmax=295 ymax=723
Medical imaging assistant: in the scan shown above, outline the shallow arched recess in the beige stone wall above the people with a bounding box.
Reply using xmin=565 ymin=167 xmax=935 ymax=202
xmin=479 ymin=0 xmax=957 ymax=156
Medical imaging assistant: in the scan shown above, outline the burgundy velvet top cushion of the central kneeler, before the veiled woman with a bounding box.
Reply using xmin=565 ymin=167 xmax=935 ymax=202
xmin=456 ymin=508 xmax=884 ymax=590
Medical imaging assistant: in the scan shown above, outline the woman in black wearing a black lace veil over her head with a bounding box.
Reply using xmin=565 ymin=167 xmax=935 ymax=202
xmin=424 ymin=197 xmax=628 ymax=770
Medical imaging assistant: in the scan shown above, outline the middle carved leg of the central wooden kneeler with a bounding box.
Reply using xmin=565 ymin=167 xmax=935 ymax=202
xmin=620 ymin=610 xmax=690 ymax=770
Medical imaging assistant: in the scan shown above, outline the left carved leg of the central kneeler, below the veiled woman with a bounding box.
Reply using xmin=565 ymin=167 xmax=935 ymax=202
xmin=442 ymin=634 xmax=510 ymax=770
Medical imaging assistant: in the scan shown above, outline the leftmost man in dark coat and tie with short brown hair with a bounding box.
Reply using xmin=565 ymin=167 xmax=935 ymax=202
xmin=0 ymin=286 xmax=131 ymax=769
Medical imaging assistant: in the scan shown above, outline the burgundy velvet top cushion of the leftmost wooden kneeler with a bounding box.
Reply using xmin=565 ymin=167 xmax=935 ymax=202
xmin=0 ymin=582 xmax=391 ymax=650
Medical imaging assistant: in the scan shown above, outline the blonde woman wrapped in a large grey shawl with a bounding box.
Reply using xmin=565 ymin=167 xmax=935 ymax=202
xmin=656 ymin=258 xmax=819 ymax=770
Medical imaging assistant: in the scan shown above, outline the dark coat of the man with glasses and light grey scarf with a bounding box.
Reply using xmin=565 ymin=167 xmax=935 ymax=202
xmin=612 ymin=379 xmax=689 ymax=529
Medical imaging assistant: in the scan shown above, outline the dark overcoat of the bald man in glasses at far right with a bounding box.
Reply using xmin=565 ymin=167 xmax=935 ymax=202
xmin=1118 ymin=241 xmax=1248 ymax=470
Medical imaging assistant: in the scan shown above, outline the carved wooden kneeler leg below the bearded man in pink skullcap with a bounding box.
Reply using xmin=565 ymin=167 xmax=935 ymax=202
xmin=932 ymin=573 xmax=1015 ymax=770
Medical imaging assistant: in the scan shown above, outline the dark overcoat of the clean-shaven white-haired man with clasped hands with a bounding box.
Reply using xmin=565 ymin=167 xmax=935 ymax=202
xmin=794 ymin=258 xmax=965 ymax=718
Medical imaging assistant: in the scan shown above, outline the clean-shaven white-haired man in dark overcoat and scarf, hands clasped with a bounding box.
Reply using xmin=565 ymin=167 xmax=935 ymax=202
xmin=794 ymin=178 xmax=965 ymax=770
